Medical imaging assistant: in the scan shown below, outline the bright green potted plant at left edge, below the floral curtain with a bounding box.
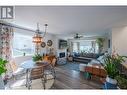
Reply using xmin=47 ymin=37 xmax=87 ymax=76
xmin=0 ymin=58 xmax=7 ymax=89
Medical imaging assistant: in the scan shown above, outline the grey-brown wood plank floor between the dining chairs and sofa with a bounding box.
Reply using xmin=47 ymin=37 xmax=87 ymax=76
xmin=52 ymin=64 xmax=102 ymax=89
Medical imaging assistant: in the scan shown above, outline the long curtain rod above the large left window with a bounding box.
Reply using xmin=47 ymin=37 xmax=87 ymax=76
xmin=0 ymin=22 xmax=41 ymax=33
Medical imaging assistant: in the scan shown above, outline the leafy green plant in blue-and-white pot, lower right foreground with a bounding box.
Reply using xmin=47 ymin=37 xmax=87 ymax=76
xmin=104 ymin=54 xmax=127 ymax=89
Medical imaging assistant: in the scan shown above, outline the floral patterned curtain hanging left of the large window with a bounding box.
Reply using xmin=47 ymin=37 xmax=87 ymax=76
xmin=0 ymin=25 xmax=13 ymax=61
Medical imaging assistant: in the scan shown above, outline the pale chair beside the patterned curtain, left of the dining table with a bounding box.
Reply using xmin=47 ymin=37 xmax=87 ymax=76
xmin=10 ymin=60 xmax=26 ymax=80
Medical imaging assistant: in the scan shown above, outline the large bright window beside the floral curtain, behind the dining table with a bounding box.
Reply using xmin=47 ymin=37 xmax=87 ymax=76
xmin=13 ymin=32 xmax=34 ymax=56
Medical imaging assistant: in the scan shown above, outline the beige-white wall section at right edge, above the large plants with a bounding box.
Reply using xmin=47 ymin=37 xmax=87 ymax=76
xmin=112 ymin=26 xmax=127 ymax=56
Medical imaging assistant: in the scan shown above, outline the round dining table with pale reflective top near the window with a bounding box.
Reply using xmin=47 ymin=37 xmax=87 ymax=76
xmin=20 ymin=60 xmax=49 ymax=87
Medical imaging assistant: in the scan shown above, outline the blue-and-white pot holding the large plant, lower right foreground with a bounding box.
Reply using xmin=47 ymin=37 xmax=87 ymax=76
xmin=104 ymin=76 xmax=117 ymax=89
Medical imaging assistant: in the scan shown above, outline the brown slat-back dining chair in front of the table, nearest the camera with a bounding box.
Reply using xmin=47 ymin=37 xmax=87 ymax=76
xmin=27 ymin=64 xmax=46 ymax=89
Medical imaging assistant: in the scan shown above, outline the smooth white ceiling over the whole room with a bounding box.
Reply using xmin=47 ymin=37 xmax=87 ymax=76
xmin=13 ymin=6 xmax=127 ymax=36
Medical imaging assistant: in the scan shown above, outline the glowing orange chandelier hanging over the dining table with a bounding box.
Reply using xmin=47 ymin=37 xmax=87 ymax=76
xmin=33 ymin=23 xmax=48 ymax=44
